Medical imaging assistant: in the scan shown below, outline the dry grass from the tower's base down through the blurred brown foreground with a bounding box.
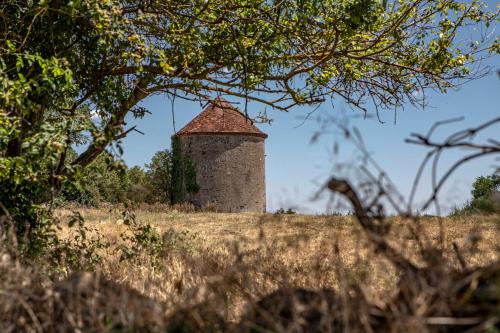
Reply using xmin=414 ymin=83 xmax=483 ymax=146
xmin=0 ymin=206 xmax=500 ymax=333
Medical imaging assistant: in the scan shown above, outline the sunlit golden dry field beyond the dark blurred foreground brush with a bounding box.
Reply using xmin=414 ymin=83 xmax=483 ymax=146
xmin=57 ymin=209 xmax=500 ymax=321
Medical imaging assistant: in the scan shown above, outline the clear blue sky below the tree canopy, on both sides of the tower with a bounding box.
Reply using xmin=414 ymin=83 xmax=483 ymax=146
xmin=119 ymin=16 xmax=500 ymax=213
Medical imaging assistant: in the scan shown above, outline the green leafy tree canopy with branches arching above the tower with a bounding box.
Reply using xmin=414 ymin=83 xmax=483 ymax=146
xmin=0 ymin=0 xmax=498 ymax=173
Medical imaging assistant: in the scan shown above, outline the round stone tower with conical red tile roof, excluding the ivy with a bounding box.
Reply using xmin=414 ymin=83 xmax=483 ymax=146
xmin=176 ymin=98 xmax=267 ymax=212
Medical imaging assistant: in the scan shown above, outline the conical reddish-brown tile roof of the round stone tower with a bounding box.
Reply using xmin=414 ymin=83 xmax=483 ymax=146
xmin=177 ymin=98 xmax=267 ymax=138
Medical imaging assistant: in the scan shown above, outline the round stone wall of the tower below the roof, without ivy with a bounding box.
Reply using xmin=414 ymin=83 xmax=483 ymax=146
xmin=180 ymin=134 xmax=266 ymax=212
